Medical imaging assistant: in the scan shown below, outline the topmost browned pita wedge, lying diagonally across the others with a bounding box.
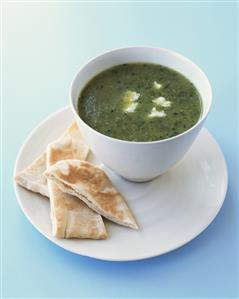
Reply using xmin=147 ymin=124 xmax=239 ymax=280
xmin=45 ymin=160 xmax=138 ymax=229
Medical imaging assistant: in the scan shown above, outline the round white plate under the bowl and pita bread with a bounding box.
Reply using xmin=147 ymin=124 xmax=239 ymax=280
xmin=15 ymin=107 xmax=227 ymax=261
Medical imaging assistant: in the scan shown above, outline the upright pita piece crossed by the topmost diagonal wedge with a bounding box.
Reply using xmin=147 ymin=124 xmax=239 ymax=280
xmin=47 ymin=123 xmax=107 ymax=239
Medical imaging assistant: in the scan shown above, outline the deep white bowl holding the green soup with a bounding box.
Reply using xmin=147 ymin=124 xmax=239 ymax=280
xmin=70 ymin=47 xmax=212 ymax=182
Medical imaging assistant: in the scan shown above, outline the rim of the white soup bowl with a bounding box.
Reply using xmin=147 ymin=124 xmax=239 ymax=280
xmin=70 ymin=46 xmax=212 ymax=145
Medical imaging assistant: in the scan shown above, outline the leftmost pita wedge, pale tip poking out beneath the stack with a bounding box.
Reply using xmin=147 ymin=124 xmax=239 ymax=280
xmin=15 ymin=153 xmax=49 ymax=197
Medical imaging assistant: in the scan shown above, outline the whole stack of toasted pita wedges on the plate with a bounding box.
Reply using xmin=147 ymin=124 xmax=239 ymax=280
xmin=15 ymin=123 xmax=138 ymax=239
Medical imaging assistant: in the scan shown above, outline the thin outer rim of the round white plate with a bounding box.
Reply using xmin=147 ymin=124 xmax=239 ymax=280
xmin=13 ymin=105 xmax=228 ymax=262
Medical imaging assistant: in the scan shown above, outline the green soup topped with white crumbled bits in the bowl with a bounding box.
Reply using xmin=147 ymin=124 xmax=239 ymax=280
xmin=78 ymin=63 xmax=202 ymax=141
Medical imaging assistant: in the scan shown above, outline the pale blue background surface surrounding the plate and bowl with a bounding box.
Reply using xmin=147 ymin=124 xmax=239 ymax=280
xmin=3 ymin=2 xmax=238 ymax=298
